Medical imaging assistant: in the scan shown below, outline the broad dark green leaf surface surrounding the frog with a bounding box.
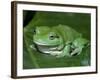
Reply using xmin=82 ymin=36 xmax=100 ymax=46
xmin=23 ymin=11 xmax=91 ymax=69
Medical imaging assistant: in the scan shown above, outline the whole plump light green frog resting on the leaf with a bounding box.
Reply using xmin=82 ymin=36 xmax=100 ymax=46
xmin=32 ymin=25 xmax=88 ymax=57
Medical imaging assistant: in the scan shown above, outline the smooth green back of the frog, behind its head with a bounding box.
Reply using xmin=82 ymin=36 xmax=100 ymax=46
xmin=55 ymin=25 xmax=81 ymax=42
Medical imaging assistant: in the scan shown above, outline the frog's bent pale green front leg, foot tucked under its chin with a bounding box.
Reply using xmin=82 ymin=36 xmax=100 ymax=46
xmin=51 ymin=45 xmax=70 ymax=58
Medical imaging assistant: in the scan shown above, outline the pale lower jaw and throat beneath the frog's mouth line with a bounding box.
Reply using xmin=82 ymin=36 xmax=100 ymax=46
xmin=36 ymin=44 xmax=58 ymax=53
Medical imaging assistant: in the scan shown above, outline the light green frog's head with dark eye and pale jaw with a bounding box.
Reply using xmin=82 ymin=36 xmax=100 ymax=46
xmin=33 ymin=26 xmax=63 ymax=53
